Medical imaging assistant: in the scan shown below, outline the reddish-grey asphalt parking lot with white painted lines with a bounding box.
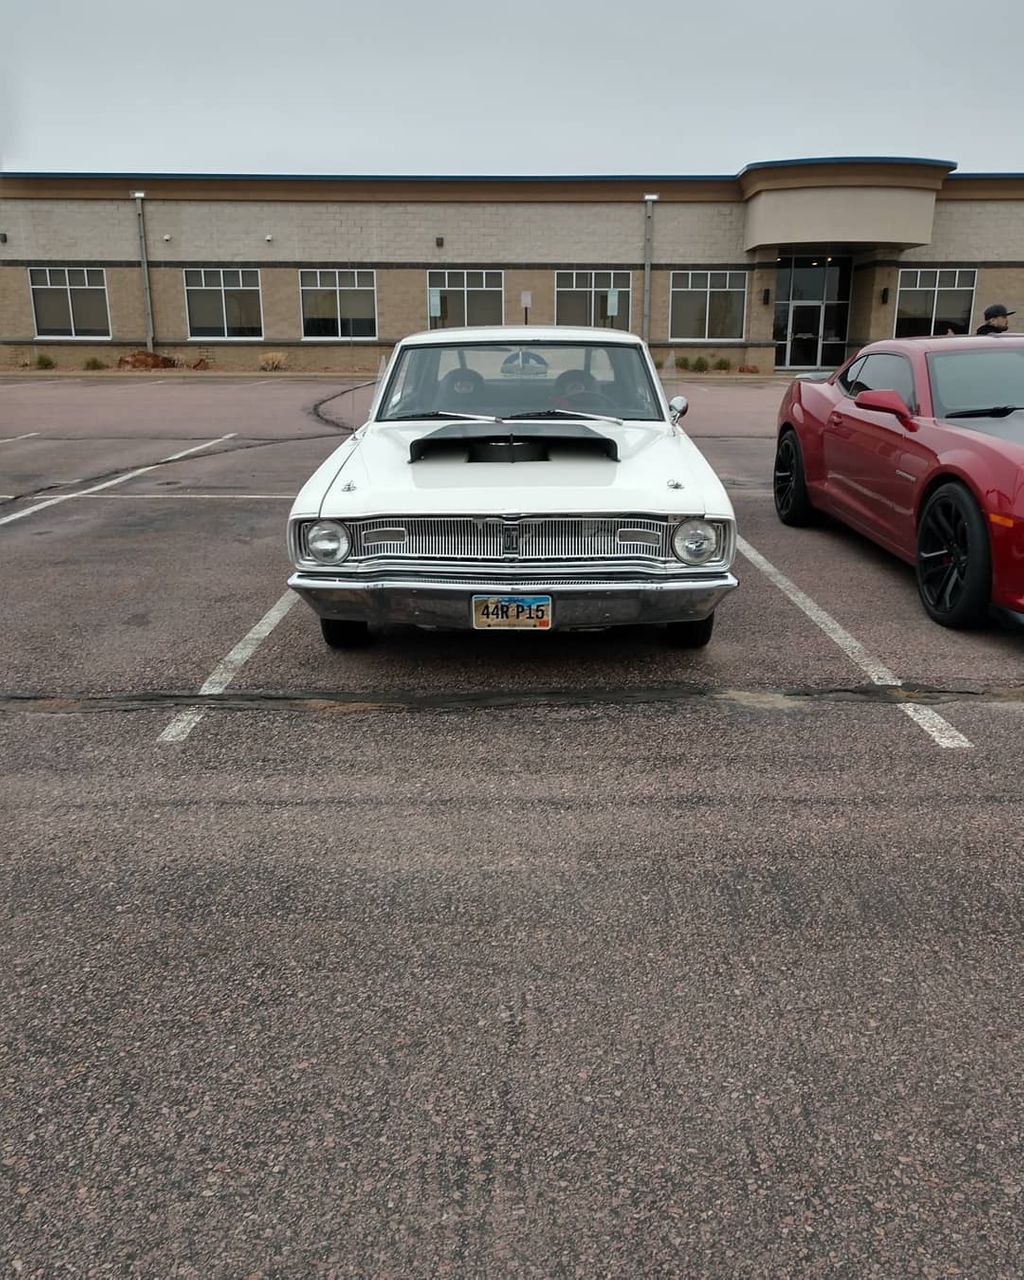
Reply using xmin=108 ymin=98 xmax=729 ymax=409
xmin=0 ymin=374 xmax=1024 ymax=1280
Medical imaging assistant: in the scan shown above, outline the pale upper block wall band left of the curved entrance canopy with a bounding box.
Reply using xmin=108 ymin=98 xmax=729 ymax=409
xmin=0 ymin=197 xmax=745 ymax=266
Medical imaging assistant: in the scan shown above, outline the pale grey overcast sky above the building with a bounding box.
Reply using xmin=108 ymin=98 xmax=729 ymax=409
xmin=0 ymin=0 xmax=1024 ymax=175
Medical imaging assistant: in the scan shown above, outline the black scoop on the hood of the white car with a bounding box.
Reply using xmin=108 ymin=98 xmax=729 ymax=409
xmin=408 ymin=422 xmax=618 ymax=462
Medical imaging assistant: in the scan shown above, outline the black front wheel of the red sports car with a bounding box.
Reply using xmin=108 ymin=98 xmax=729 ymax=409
xmin=918 ymin=484 xmax=992 ymax=630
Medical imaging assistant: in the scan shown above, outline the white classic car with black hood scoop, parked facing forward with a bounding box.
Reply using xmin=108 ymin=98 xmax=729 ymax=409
xmin=288 ymin=326 xmax=736 ymax=648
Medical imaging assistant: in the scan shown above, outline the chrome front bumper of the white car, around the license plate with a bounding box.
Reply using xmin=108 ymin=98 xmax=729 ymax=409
xmin=288 ymin=571 xmax=737 ymax=631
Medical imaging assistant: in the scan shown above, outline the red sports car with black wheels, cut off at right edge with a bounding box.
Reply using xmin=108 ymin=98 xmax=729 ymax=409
xmin=774 ymin=335 xmax=1024 ymax=627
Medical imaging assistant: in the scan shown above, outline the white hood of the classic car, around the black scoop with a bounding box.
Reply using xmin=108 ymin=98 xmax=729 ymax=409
xmin=292 ymin=420 xmax=732 ymax=520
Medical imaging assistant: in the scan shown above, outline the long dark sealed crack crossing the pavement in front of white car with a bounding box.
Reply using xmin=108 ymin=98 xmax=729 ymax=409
xmin=0 ymin=685 xmax=1024 ymax=716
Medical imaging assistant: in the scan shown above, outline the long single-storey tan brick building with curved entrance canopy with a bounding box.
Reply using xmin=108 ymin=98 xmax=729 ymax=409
xmin=0 ymin=159 xmax=1024 ymax=372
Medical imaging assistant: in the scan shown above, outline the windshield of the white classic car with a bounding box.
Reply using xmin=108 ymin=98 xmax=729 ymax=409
xmin=376 ymin=342 xmax=662 ymax=422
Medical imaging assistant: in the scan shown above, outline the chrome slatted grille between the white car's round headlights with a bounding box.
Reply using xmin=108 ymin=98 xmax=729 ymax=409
xmin=348 ymin=516 xmax=672 ymax=563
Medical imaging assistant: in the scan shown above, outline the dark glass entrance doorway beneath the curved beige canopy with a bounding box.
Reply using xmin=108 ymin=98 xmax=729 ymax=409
xmin=774 ymin=255 xmax=852 ymax=369
